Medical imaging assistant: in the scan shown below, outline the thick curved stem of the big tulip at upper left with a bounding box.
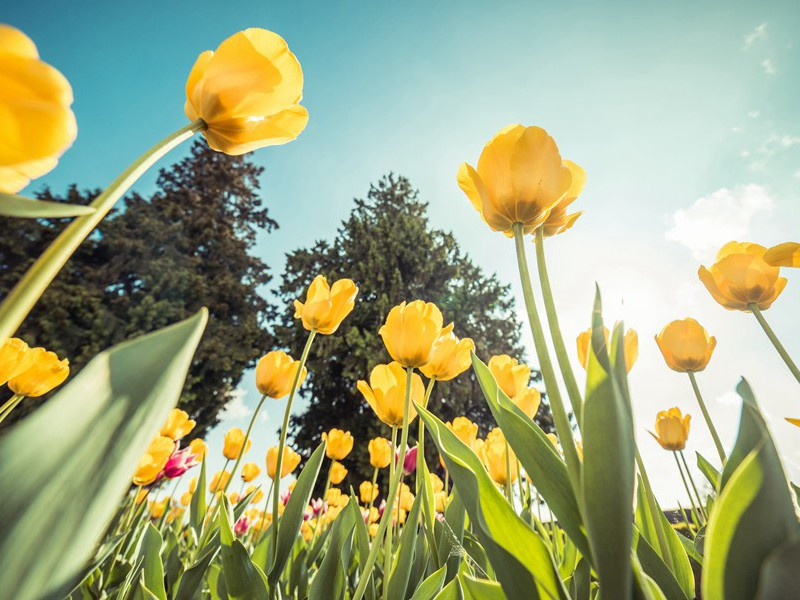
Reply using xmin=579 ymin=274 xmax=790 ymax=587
xmin=0 ymin=119 xmax=206 ymax=342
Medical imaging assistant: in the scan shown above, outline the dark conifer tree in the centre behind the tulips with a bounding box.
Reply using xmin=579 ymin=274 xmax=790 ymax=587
xmin=275 ymin=174 xmax=549 ymax=487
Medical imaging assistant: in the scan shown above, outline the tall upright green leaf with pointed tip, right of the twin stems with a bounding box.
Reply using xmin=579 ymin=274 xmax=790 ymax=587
xmin=582 ymin=292 xmax=634 ymax=600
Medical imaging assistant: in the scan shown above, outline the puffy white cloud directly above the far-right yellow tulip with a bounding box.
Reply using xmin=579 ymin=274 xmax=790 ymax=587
xmin=664 ymin=183 xmax=775 ymax=261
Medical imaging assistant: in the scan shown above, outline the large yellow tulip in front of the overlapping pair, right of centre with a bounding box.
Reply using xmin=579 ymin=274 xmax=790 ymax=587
xmin=457 ymin=125 xmax=572 ymax=237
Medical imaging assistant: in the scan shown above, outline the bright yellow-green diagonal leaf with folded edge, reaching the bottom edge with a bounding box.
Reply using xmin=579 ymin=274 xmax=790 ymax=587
xmin=416 ymin=405 xmax=566 ymax=598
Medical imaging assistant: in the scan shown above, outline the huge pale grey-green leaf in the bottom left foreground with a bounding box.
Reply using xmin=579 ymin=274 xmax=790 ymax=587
xmin=0 ymin=309 xmax=208 ymax=600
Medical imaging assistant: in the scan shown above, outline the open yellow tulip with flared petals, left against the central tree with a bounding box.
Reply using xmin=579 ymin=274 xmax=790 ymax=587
xmin=294 ymin=275 xmax=358 ymax=335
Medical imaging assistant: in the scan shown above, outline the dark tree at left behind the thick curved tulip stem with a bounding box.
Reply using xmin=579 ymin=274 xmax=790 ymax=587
xmin=0 ymin=141 xmax=277 ymax=435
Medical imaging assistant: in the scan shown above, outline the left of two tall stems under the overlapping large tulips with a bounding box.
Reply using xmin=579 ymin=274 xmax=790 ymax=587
xmin=513 ymin=223 xmax=581 ymax=497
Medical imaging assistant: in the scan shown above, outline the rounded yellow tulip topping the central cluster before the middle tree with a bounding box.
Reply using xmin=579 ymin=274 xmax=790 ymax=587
xmin=378 ymin=300 xmax=442 ymax=367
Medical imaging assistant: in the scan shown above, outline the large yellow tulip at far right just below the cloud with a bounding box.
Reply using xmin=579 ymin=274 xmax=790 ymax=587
xmin=697 ymin=242 xmax=786 ymax=312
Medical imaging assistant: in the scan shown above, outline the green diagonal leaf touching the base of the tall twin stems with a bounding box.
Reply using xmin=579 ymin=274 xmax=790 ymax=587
xmin=472 ymin=353 xmax=590 ymax=557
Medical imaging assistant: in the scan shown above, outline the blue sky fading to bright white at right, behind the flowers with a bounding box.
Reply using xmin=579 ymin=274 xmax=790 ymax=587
xmin=4 ymin=0 xmax=800 ymax=504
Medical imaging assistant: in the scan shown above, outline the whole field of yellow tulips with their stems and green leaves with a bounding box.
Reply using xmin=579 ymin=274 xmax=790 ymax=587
xmin=0 ymin=21 xmax=800 ymax=600
